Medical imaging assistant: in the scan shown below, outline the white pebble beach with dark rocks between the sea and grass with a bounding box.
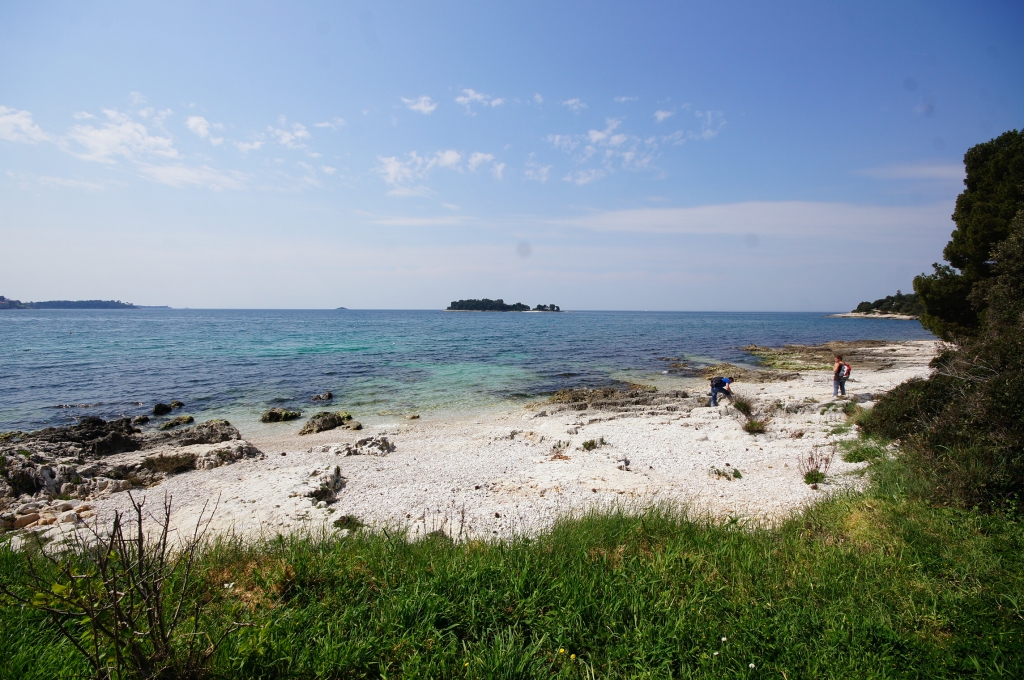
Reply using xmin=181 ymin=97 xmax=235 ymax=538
xmin=0 ymin=341 xmax=938 ymax=541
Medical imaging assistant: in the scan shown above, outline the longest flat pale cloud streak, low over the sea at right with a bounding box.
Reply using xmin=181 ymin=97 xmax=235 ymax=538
xmin=557 ymin=200 xmax=949 ymax=240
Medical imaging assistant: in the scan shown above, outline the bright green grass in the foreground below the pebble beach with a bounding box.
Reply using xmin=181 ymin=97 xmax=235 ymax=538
xmin=0 ymin=444 xmax=1024 ymax=680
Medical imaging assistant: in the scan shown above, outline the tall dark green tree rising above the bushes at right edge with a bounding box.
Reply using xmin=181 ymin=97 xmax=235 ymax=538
xmin=913 ymin=130 xmax=1024 ymax=340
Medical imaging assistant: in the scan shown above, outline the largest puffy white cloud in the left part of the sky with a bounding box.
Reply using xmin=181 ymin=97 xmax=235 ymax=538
xmin=67 ymin=109 xmax=179 ymax=164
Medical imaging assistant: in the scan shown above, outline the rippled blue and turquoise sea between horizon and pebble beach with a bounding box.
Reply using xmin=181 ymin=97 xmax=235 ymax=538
xmin=0 ymin=309 xmax=932 ymax=430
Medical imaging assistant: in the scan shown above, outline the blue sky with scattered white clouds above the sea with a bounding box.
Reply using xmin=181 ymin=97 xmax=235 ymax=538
xmin=0 ymin=1 xmax=1024 ymax=310
